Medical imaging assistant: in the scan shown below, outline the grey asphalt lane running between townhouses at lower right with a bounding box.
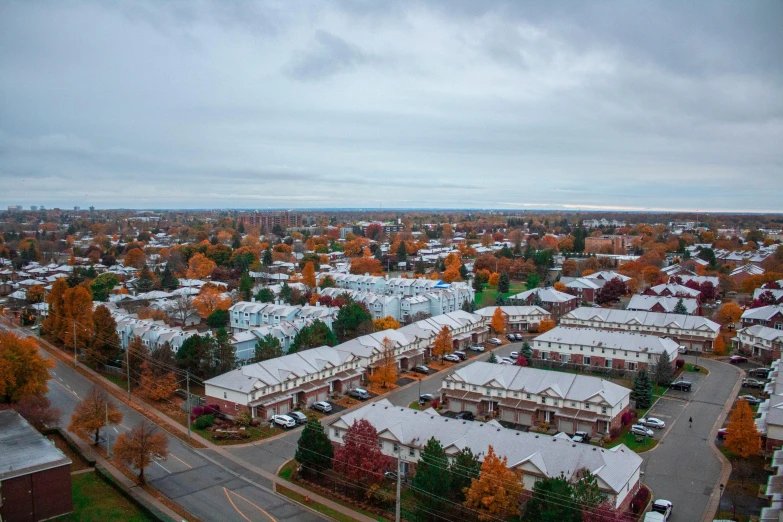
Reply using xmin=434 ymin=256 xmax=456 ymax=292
xmin=642 ymin=356 xmax=741 ymax=522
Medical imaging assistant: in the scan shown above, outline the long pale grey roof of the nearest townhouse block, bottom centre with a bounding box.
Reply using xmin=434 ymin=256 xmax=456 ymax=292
xmin=330 ymin=399 xmax=642 ymax=493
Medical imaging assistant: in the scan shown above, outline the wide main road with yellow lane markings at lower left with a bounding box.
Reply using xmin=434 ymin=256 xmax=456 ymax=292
xmin=0 ymin=325 xmax=326 ymax=522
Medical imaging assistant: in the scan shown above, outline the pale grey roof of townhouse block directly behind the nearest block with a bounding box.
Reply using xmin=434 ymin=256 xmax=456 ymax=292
xmin=444 ymin=362 xmax=631 ymax=406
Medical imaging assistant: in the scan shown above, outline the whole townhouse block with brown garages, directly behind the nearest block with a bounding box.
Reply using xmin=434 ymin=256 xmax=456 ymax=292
xmin=440 ymin=362 xmax=630 ymax=436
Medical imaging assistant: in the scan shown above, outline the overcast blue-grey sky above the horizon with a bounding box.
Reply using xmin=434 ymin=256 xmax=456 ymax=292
xmin=0 ymin=0 xmax=783 ymax=211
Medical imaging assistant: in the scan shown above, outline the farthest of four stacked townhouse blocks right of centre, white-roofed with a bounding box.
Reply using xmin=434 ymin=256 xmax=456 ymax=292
xmin=560 ymin=307 xmax=720 ymax=352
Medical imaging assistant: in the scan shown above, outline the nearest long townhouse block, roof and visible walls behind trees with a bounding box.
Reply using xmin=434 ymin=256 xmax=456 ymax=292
xmin=327 ymin=399 xmax=642 ymax=510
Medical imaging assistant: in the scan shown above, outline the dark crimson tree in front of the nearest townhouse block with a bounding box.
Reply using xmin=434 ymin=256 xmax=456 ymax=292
xmin=332 ymin=419 xmax=395 ymax=491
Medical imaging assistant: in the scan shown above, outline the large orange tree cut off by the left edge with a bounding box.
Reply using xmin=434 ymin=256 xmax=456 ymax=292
xmin=0 ymin=330 xmax=54 ymax=404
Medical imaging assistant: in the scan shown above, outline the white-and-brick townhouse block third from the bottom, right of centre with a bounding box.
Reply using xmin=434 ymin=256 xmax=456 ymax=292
xmin=532 ymin=326 xmax=679 ymax=371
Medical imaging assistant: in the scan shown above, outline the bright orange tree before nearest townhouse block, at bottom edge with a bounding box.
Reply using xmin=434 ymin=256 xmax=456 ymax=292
xmin=465 ymin=445 xmax=523 ymax=520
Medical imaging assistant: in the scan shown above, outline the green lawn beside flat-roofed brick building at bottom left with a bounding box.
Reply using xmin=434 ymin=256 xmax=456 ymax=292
xmin=56 ymin=473 xmax=153 ymax=522
